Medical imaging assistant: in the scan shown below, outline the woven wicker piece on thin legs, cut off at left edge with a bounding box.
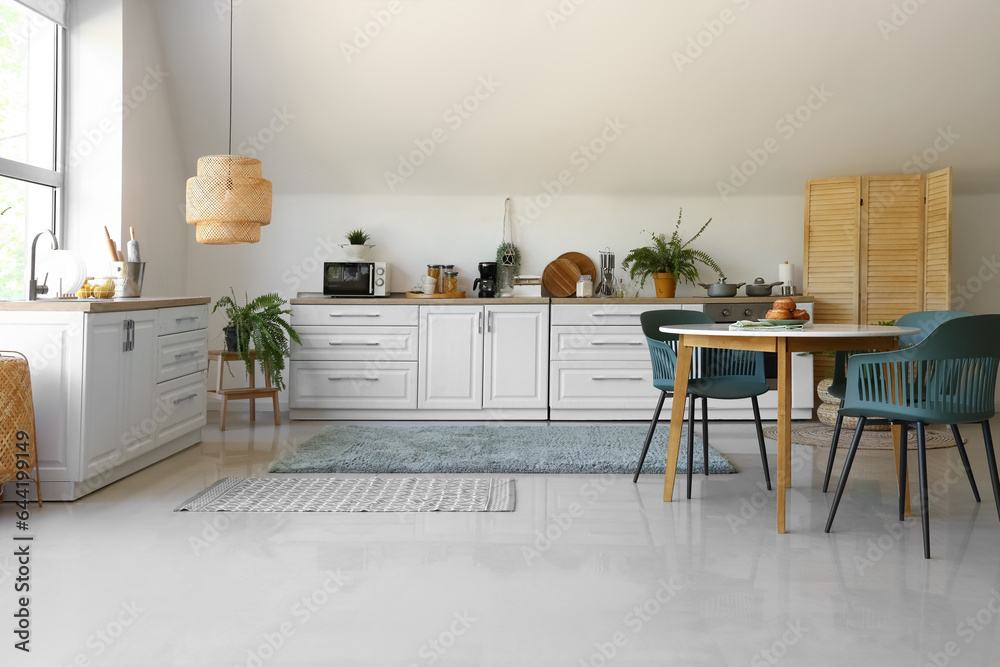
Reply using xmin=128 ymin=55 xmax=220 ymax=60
xmin=0 ymin=351 xmax=42 ymax=505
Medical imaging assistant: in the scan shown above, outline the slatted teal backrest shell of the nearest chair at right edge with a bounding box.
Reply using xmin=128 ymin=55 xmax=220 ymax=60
xmin=845 ymin=315 xmax=1000 ymax=424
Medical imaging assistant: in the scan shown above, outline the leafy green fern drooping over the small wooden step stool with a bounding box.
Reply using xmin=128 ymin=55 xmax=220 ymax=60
xmin=212 ymin=287 xmax=302 ymax=389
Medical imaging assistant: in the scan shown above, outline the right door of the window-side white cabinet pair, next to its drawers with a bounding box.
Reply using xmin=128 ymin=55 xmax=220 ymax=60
xmin=118 ymin=310 xmax=158 ymax=461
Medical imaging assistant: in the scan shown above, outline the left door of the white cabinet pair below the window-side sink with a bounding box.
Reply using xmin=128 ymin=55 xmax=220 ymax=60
xmin=77 ymin=313 xmax=127 ymax=481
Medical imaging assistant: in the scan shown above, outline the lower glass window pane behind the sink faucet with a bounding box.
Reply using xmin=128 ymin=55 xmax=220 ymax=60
xmin=0 ymin=176 xmax=58 ymax=300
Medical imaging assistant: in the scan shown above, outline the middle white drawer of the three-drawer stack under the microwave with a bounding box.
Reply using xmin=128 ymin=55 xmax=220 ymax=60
xmin=292 ymin=326 xmax=417 ymax=362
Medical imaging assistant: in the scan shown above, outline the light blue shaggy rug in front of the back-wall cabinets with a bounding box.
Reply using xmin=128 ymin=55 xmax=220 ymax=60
xmin=270 ymin=424 xmax=737 ymax=475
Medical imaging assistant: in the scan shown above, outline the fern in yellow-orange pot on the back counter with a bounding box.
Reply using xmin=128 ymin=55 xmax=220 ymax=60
xmin=622 ymin=208 xmax=722 ymax=298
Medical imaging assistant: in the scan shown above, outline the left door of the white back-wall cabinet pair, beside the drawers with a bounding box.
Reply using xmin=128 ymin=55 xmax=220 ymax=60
xmin=417 ymin=306 xmax=484 ymax=410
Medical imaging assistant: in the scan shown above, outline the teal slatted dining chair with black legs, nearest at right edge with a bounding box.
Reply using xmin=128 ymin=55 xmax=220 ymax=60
xmin=826 ymin=315 xmax=1000 ymax=558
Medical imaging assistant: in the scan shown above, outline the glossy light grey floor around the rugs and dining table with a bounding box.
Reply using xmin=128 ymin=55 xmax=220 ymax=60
xmin=7 ymin=413 xmax=1000 ymax=667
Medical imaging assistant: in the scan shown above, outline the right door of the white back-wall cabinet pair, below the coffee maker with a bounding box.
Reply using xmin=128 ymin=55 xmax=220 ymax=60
xmin=483 ymin=305 xmax=549 ymax=408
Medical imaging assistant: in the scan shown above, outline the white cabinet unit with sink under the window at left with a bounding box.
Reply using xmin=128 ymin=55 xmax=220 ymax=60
xmin=0 ymin=299 xmax=208 ymax=500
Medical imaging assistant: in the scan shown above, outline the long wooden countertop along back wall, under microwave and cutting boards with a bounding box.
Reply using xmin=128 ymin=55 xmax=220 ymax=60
xmin=292 ymin=292 xmax=814 ymax=306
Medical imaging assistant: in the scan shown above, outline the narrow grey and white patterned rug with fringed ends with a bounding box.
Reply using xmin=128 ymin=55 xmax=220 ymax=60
xmin=174 ymin=477 xmax=514 ymax=512
